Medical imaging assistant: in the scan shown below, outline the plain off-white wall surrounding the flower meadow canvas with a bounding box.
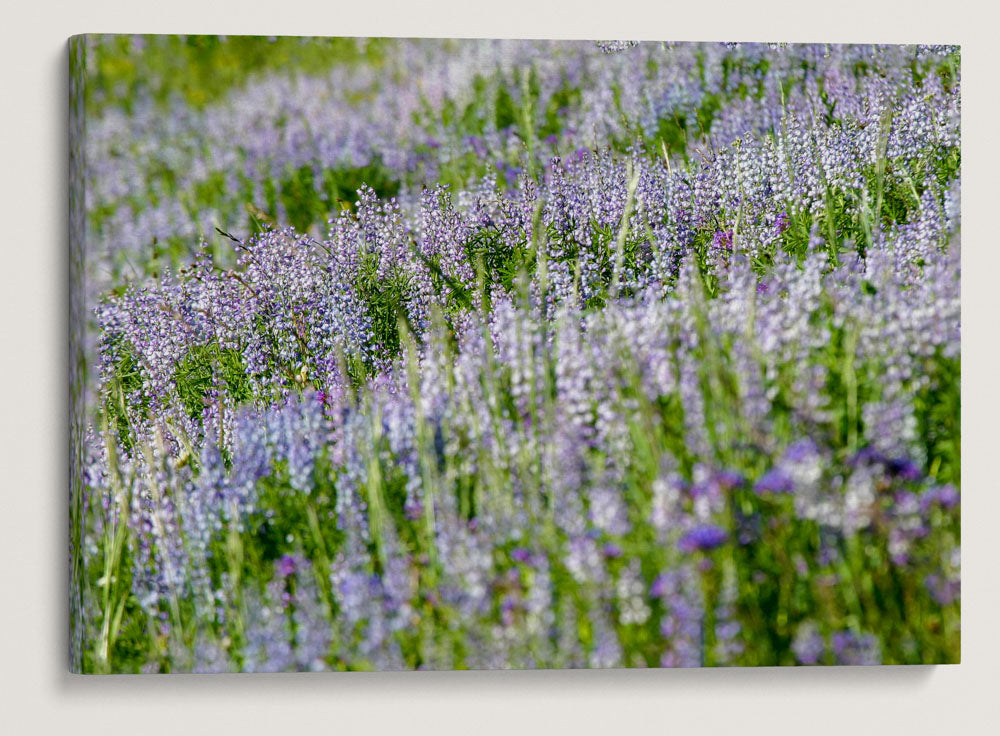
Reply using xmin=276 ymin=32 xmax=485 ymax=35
xmin=0 ymin=0 xmax=1000 ymax=736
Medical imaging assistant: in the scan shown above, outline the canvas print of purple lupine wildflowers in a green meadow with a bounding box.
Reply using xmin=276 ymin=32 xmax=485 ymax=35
xmin=68 ymin=35 xmax=962 ymax=673
